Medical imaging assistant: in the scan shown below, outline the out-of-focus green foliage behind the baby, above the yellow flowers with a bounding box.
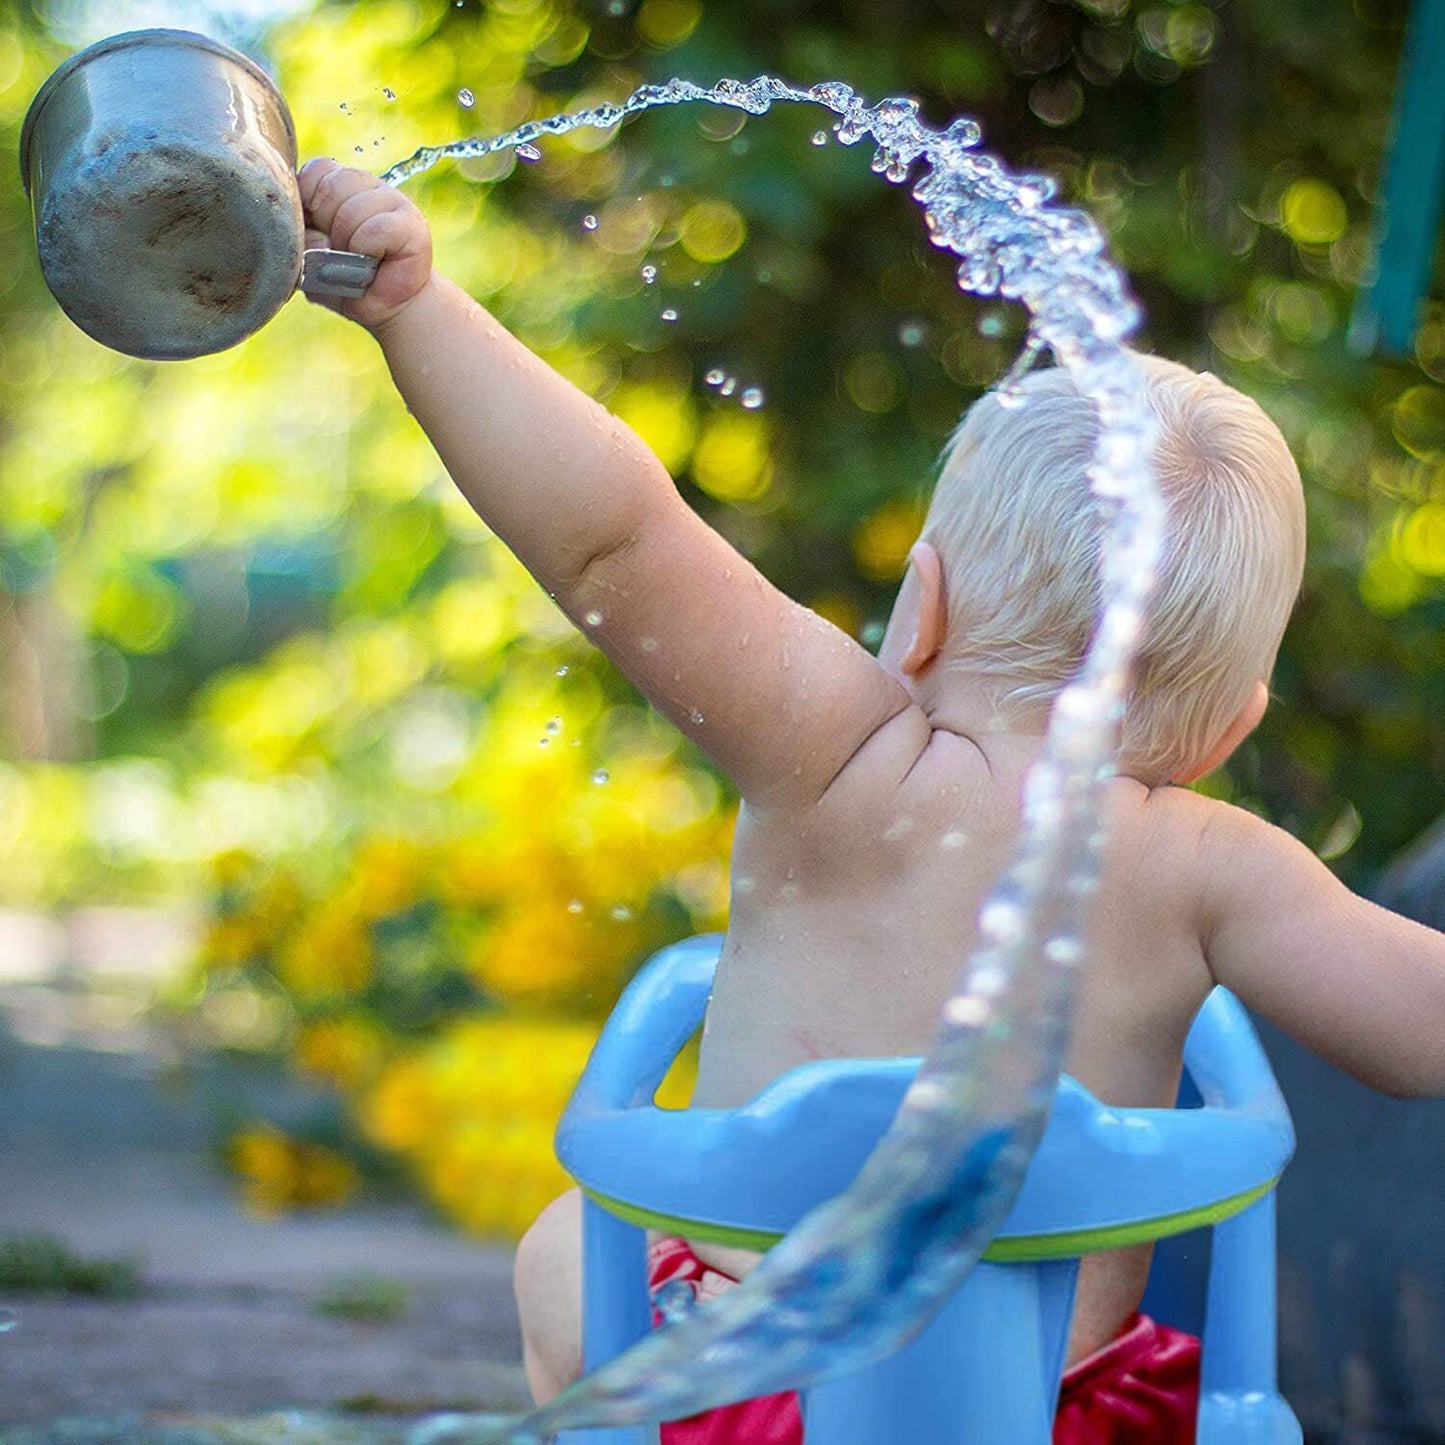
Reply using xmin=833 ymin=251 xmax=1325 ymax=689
xmin=0 ymin=0 xmax=1445 ymax=899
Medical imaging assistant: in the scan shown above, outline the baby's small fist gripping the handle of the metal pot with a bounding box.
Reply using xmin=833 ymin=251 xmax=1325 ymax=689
xmin=298 ymin=158 xmax=432 ymax=329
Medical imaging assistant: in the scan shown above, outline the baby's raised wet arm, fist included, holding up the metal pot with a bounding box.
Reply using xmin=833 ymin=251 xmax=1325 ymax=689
xmin=294 ymin=162 xmax=909 ymax=803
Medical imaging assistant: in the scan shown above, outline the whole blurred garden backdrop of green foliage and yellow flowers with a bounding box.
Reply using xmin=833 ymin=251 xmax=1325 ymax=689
xmin=0 ymin=0 xmax=1445 ymax=1439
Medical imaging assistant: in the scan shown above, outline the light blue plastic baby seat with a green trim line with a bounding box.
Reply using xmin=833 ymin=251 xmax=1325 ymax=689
xmin=556 ymin=935 xmax=1301 ymax=1445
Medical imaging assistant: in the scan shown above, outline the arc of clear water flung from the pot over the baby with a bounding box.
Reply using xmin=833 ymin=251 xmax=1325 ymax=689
xmin=383 ymin=77 xmax=1163 ymax=1445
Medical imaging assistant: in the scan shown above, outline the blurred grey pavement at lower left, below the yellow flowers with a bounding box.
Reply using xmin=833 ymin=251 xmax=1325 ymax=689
xmin=0 ymin=919 xmax=526 ymax=1445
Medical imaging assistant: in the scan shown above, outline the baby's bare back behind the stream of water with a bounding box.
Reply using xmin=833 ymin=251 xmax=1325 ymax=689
xmin=696 ymin=709 xmax=1211 ymax=1358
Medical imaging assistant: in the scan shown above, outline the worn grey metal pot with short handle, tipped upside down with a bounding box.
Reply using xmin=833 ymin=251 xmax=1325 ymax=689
xmin=20 ymin=30 xmax=376 ymax=360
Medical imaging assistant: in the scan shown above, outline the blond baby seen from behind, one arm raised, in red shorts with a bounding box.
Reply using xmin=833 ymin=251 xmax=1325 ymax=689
xmin=301 ymin=160 xmax=1445 ymax=1442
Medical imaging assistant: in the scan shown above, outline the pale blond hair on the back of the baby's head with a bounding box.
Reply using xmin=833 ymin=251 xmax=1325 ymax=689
xmin=923 ymin=355 xmax=1305 ymax=782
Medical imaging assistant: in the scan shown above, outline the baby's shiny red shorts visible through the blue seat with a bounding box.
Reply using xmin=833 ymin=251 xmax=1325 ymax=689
xmin=647 ymin=1238 xmax=1199 ymax=1445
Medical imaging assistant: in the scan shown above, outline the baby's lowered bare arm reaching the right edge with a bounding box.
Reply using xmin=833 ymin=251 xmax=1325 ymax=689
xmin=1201 ymin=805 xmax=1445 ymax=1097
